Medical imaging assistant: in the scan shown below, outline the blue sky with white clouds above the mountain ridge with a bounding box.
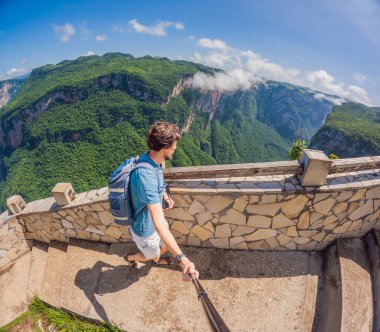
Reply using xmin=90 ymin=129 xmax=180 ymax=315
xmin=0 ymin=0 xmax=380 ymax=106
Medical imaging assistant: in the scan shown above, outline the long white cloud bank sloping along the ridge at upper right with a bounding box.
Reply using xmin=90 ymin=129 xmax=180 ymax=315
xmin=190 ymin=38 xmax=372 ymax=105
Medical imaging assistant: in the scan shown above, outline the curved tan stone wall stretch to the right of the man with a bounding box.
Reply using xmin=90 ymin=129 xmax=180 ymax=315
xmin=166 ymin=170 xmax=380 ymax=250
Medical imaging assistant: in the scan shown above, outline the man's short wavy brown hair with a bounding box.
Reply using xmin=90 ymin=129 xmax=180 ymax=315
xmin=147 ymin=122 xmax=181 ymax=151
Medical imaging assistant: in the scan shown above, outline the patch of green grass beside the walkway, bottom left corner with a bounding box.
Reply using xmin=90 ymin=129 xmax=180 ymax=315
xmin=0 ymin=297 xmax=123 ymax=332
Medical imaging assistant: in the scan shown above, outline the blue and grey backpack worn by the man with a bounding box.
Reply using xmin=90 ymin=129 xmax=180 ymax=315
xmin=108 ymin=156 xmax=158 ymax=226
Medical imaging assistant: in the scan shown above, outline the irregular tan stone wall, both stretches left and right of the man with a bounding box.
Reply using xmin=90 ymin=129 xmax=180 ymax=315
xmin=2 ymin=165 xmax=380 ymax=268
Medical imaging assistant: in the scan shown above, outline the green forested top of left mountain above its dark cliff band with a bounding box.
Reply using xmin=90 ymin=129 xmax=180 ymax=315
xmin=3 ymin=53 xmax=202 ymax=115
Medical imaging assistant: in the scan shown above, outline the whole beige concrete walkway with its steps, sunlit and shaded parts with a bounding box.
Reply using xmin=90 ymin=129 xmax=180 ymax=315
xmin=5 ymin=233 xmax=380 ymax=332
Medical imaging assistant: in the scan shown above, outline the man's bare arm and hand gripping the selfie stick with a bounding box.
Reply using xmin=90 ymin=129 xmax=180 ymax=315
xmin=147 ymin=203 xmax=199 ymax=281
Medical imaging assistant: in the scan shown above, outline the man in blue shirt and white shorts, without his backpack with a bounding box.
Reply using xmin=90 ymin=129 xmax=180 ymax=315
xmin=124 ymin=122 xmax=199 ymax=281
